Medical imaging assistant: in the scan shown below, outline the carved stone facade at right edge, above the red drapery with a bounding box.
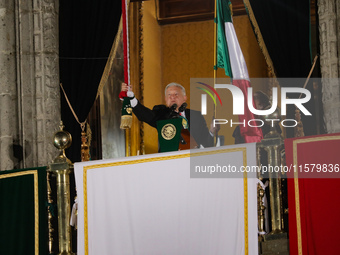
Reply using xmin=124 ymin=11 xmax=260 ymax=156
xmin=318 ymin=0 xmax=340 ymax=133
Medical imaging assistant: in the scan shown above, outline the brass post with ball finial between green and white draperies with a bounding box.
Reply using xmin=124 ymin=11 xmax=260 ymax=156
xmin=50 ymin=122 xmax=74 ymax=255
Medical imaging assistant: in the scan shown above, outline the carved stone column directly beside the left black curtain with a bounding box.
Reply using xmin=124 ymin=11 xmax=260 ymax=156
xmin=30 ymin=0 xmax=61 ymax=166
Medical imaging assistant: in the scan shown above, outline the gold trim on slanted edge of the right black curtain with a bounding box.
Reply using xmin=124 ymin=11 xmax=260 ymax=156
xmin=243 ymin=0 xmax=276 ymax=78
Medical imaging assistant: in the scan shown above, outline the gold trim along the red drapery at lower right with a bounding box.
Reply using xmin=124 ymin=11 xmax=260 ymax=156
xmin=293 ymin=136 xmax=340 ymax=255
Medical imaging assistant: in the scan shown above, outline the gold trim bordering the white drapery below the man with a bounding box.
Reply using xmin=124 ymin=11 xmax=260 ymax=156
xmin=83 ymin=147 xmax=249 ymax=255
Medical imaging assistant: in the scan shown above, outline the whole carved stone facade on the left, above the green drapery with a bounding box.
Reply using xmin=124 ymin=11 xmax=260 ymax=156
xmin=0 ymin=0 xmax=60 ymax=170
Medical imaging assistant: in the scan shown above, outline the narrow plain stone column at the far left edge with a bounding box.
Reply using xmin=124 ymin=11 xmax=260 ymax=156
xmin=0 ymin=0 xmax=18 ymax=170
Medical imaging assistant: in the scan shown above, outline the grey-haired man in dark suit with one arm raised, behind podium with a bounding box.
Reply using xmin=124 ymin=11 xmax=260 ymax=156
xmin=121 ymin=82 xmax=219 ymax=147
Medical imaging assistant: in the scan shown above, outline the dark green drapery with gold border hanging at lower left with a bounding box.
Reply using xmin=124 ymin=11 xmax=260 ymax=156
xmin=0 ymin=167 xmax=48 ymax=255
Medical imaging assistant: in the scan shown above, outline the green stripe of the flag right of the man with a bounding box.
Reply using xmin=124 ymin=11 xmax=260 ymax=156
xmin=215 ymin=0 xmax=233 ymax=78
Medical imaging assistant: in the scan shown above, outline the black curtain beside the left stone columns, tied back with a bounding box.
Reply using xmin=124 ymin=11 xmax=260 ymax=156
xmin=59 ymin=0 xmax=121 ymax=162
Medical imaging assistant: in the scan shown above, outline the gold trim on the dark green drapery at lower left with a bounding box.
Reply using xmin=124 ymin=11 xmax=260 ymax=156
xmin=0 ymin=170 xmax=39 ymax=255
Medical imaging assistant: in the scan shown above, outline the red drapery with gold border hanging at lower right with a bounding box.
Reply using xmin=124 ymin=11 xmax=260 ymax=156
xmin=285 ymin=133 xmax=340 ymax=255
